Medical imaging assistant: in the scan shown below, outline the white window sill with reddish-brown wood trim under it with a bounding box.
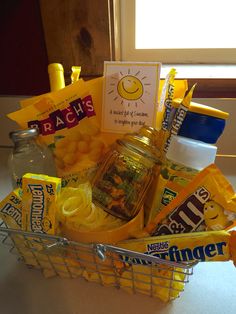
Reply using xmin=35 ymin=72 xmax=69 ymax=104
xmin=161 ymin=64 xmax=236 ymax=98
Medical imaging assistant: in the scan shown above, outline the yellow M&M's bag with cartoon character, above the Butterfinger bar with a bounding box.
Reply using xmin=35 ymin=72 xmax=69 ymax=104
xmin=145 ymin=164 xmax=236 ymax=235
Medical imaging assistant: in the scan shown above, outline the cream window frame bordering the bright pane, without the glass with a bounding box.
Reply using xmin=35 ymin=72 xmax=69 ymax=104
xmin=119 ymin=0 xmax=236 ymax=64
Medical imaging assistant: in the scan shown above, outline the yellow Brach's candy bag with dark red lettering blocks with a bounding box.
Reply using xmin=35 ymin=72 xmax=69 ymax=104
xmin=8 ymin=78 xmax=118 ymax=180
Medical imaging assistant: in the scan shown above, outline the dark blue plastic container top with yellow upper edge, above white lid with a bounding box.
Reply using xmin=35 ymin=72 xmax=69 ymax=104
xmin=174 ymin=99 xmax=229 ymax=144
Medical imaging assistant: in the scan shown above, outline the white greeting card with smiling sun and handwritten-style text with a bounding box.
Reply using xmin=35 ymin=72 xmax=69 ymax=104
xmin=102 ymin=62 xmax=161 ymax=133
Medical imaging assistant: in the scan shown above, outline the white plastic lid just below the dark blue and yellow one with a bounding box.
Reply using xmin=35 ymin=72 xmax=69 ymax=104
xmin=166 ymin=135 xmax=217 ymax=170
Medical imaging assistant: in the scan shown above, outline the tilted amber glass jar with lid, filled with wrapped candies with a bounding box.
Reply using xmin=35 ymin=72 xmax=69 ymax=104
xmin=93 ymin=126 xmax=160 ymax=220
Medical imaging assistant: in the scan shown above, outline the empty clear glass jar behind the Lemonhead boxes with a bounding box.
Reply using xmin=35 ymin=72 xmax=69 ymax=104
xmin=8 ymin=128 xmax=56 ymax=188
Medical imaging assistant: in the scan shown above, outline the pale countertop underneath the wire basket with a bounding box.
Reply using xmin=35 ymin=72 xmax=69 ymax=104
xmin=0 ymin=148 xmax=236 ymax=314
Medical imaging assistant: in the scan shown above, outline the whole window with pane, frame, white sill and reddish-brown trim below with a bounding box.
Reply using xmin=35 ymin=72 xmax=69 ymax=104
xmin=113 ymin=0 xmax=236 ymax=98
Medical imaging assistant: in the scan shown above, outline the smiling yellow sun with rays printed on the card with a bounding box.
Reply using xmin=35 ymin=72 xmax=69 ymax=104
xmin=108 ymin=68 xmax=151 ymax=107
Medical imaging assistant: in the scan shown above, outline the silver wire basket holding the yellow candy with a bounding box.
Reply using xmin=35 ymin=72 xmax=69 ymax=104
xmin=0 ymin=222 xmax=197 ymax=302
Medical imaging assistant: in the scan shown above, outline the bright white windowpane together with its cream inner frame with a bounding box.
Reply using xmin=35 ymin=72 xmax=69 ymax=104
xmin=120 ymin=0 xmax=236 ymax=64
